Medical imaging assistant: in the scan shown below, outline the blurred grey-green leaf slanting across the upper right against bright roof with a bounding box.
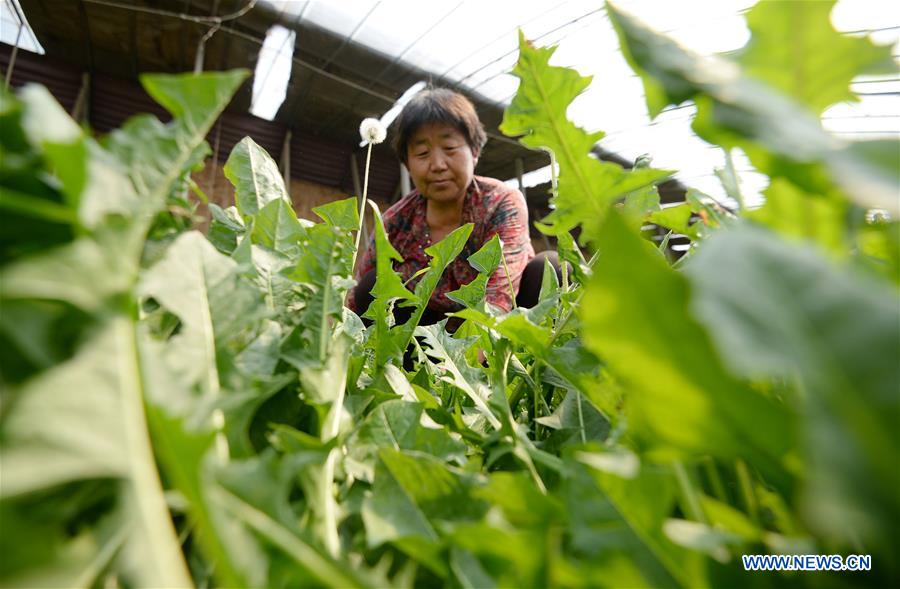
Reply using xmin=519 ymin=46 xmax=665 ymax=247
xmin=609 ymin=3 xmax=900 ymax=213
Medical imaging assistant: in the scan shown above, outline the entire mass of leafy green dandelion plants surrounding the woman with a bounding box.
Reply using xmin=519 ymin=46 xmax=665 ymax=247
xmin=0 ymin=8 xmax=900 ymax=587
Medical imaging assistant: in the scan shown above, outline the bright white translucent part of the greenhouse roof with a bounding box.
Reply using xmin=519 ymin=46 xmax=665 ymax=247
xmin=258 ymin=0 xmax=900 ymax=202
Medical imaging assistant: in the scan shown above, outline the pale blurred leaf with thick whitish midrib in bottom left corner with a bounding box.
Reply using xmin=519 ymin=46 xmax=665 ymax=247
xmin=0 ymin=317 xmax=190 ymax=586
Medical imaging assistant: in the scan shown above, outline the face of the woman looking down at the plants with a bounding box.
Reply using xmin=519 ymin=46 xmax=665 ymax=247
xmin=406 ymin=123 xmax=478 ymax=203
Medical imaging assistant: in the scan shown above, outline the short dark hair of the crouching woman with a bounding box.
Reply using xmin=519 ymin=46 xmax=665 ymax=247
xmin=393 ymin=88 xmax=487 ymax=164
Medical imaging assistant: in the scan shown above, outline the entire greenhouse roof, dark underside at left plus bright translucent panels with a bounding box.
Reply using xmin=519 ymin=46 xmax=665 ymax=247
xmin=3 ymin=0 xmax=900 ymax=203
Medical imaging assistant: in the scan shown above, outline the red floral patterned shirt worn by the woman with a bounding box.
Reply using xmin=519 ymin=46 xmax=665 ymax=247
xmin=348 ymin=176 xmax=534 ymax=313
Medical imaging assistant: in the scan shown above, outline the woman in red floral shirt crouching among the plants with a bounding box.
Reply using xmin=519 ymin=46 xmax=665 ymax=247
xmin=348 ymin=88 xmax=555 ymax=325
